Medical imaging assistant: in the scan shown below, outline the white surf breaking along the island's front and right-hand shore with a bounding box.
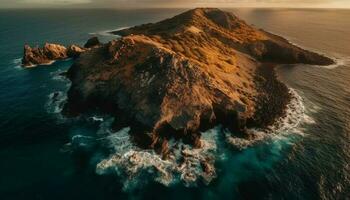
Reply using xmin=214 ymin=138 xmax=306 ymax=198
xmin=67 ymin=89 xmax=312 ymax=191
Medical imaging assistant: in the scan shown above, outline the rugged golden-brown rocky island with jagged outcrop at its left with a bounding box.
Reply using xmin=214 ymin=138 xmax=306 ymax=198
xmin=22 ymin=8 xmax=334 ymax=157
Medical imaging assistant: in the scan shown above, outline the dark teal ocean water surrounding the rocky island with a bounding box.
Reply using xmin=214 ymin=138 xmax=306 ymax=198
xmin=0 ymin=8 xmax=350 ymax=200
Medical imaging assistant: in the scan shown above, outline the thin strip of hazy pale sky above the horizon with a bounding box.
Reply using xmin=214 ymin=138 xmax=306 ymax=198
xmin=0 ymin=0 xmax=350 ymax=8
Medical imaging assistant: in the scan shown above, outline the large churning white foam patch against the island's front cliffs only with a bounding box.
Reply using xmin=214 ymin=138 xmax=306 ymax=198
xmin=96 ymin=123 xmax=219 ymax=190
